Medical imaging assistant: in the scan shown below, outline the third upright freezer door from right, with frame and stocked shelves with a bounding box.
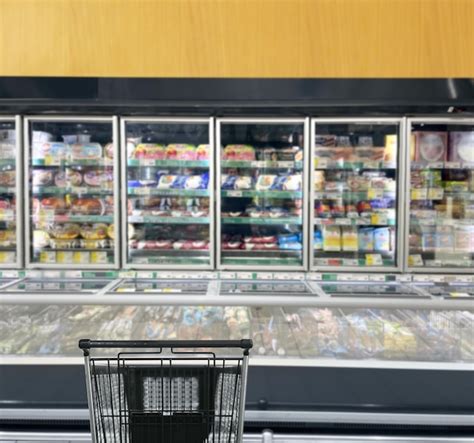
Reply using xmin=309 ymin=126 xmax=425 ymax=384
xmin=216 ymin=118 xmax=308 ymax=270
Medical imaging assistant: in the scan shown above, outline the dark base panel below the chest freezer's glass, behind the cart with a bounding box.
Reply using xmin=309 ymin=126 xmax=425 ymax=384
xmin=0 ymin=365 xmax=474 ymax=415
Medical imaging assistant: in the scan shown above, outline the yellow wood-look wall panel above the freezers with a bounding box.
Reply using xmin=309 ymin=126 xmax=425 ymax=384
xmin=0 ymin=0 xmax=474 ymax=77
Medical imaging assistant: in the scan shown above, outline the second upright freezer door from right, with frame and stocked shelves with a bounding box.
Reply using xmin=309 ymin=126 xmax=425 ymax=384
xmin=310 ymin=118 xmax=403 ymax=271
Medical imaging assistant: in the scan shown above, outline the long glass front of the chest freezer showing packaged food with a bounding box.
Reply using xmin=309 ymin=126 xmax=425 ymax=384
xmin=0 ymin=305 xmax=474 ymax=367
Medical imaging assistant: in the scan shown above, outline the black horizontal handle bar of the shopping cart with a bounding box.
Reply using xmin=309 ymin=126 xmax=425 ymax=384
xmin=79 ymin=338 xmax=253 ymax=355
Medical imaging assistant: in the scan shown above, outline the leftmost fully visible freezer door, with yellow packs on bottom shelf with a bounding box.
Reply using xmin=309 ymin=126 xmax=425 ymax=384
xmin=24 ymin=116 xmax=120 ymax=269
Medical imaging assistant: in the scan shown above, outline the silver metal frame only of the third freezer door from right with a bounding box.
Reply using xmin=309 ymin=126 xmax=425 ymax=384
xmin=216 ymin=117 xmax=308 ymax=271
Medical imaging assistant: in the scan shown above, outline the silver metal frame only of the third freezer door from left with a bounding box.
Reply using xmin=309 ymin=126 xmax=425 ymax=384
xmin=120 ymin=117 xmax=214 ymax=271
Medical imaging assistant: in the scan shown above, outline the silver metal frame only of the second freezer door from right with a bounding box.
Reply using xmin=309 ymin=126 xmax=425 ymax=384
xmin=310 ymin=117 xmax=403 ymax=273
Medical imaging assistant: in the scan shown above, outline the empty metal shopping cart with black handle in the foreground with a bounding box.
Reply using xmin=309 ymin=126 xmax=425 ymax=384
xmin=79 ymin=339 xmax=252 ymax=443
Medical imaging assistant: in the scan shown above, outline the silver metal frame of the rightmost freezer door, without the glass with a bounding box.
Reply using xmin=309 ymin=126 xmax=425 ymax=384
xmin=405 ymin=117 xmax=474 ymax=274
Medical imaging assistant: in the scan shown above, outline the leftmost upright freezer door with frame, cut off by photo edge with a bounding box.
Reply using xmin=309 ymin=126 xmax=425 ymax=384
xmin=0 ymin=116 xmax=23 ymax=268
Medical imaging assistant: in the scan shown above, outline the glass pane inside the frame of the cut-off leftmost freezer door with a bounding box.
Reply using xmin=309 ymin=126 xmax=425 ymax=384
xmin=0 ymin=120 xmax=17 ymax=266
